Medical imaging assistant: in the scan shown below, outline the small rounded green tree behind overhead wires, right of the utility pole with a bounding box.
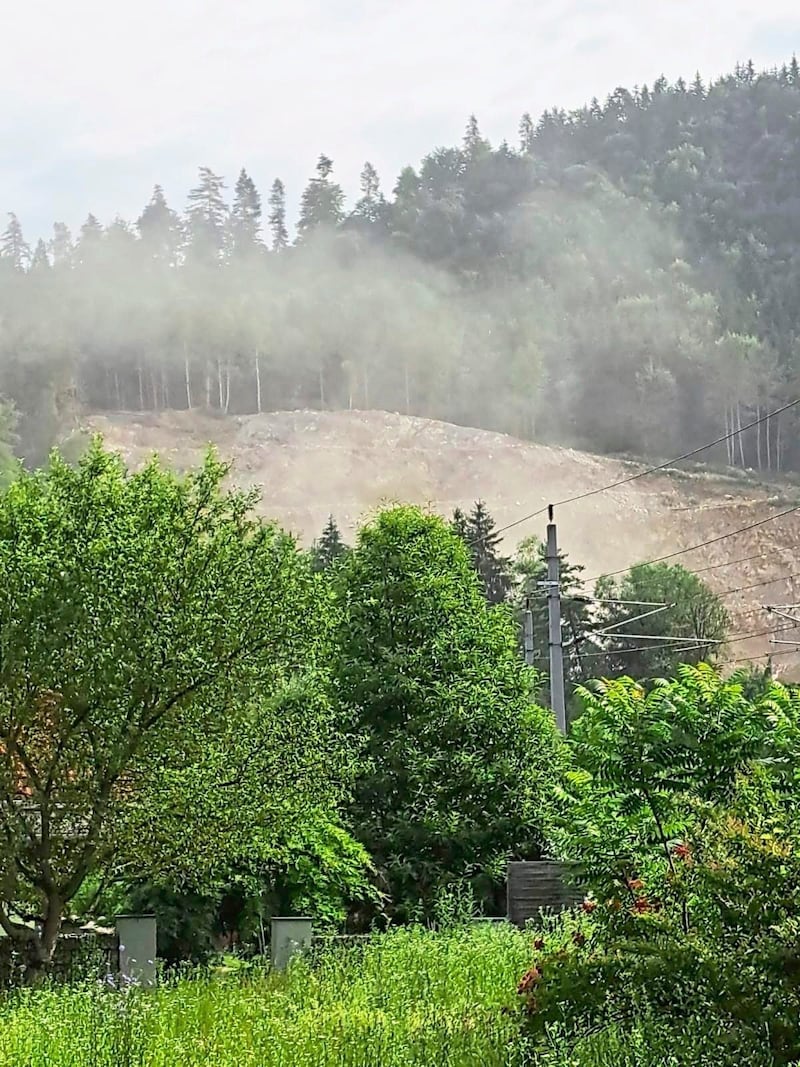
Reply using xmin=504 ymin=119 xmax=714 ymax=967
xmin=585 ymin=563 xmax=730 ymax=679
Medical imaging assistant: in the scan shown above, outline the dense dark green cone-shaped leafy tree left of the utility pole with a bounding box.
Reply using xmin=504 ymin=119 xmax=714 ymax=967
xmin=334 ymin=508 xmax=560 ymax=917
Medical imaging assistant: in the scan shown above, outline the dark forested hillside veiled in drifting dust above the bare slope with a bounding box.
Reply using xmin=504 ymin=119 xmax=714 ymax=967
xmin=0 ymin=60 xmax=800 ymax=471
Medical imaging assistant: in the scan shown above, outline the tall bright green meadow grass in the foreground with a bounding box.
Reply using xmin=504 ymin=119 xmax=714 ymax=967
xmin=0 ymin=926 xmax=776 ymax=1067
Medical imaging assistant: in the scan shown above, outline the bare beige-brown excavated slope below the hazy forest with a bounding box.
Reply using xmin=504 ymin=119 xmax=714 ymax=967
xmin=84 ymin=411 xmax=800 ymax=676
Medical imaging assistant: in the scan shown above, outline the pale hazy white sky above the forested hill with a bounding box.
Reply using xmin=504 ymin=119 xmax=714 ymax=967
xmin=0 ymin=0 xmax=800 ymax=238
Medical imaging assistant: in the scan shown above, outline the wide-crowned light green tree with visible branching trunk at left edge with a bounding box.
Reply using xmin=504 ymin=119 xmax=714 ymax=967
xmin=0 ymin=441 xmax=349 ymax=975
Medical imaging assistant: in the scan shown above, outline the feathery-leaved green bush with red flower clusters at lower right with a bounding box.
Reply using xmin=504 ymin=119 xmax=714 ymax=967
xmin=519 ymin=667 xmax=800 ymax=1064
